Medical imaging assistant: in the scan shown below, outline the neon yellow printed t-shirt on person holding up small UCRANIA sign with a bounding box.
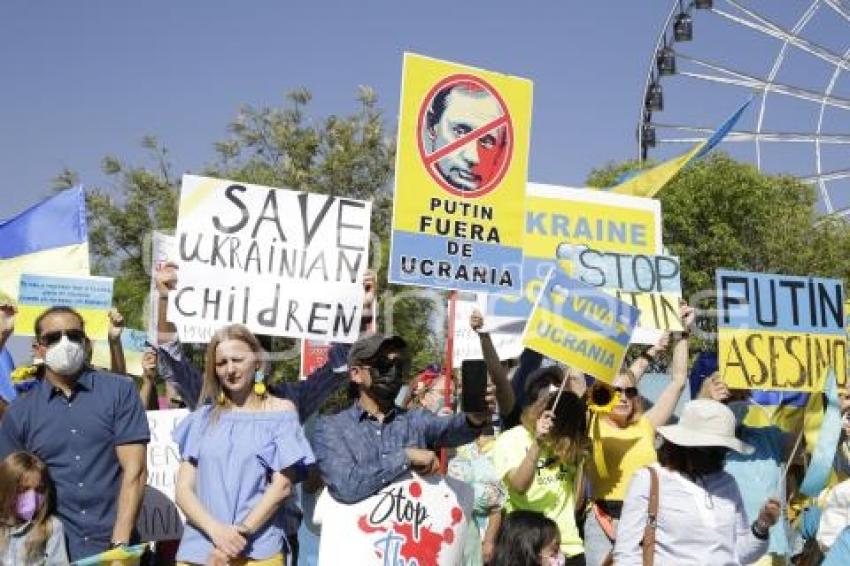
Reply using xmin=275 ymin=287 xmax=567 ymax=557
xmin=489 ymin=425 xmax=584 ymax=556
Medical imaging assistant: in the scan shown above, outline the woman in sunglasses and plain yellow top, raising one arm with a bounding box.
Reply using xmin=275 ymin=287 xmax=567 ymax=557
xmin=584 ymin=305 xmax=694 ymax=566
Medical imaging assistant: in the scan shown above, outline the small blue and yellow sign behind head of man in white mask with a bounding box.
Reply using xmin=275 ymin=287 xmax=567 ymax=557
xmin=15 ymin=273 xmax=112 ymax=340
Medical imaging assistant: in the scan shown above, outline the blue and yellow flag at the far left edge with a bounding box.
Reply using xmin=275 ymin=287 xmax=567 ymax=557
xmin=0 ymin=187 xmax=89 ymax=303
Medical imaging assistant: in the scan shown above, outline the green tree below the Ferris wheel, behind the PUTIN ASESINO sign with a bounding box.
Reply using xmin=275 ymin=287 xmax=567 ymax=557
xmin=587 ymin=153 xmax=850 ymax=332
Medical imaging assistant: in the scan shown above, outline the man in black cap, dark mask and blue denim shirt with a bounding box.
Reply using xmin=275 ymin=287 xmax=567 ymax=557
xmin=313 ymin=335 xmax=495 ymax=503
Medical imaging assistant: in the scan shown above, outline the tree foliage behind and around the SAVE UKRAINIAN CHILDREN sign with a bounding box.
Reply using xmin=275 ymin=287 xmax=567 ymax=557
xmin=55 ymin=90 xmax=442 ymax=377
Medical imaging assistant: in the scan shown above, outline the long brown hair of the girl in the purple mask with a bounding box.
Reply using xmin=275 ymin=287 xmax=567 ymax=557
xmin=0 ymin=452 xmax=53 ymax=562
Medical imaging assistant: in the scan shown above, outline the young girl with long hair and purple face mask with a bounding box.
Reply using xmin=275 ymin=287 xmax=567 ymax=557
xmin=0 ymin=452 xmax=68 ymax=566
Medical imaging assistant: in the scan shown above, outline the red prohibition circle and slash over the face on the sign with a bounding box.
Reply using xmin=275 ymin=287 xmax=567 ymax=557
xmin=416 ymin=74 xmax=514 ymax=198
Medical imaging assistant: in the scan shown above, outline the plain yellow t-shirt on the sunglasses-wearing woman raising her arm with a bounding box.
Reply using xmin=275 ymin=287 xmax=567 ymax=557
xmin=588 ymin=416 xmax=658 ymax=501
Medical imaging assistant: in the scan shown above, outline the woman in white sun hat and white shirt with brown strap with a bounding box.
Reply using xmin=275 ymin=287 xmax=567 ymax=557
xmin=614 ymin=399 xmax=780 ymax=566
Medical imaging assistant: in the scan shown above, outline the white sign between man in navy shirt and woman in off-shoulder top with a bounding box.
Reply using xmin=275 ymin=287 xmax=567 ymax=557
xmin=136 ymin=409 xmax=189 ymax=541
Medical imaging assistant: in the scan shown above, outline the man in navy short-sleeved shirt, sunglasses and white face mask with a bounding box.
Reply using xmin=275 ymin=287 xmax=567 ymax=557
xmin=0 ymin=307 xmax=150 ymax=561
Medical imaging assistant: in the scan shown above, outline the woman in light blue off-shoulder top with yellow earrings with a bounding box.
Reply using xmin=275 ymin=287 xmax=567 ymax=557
xmin=174 ymin=325 xmax=315 ymax=566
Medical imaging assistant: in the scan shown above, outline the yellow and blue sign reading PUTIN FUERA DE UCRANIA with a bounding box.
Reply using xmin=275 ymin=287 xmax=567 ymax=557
xmin=389 ymin=53 xmax=532 ymax=294
